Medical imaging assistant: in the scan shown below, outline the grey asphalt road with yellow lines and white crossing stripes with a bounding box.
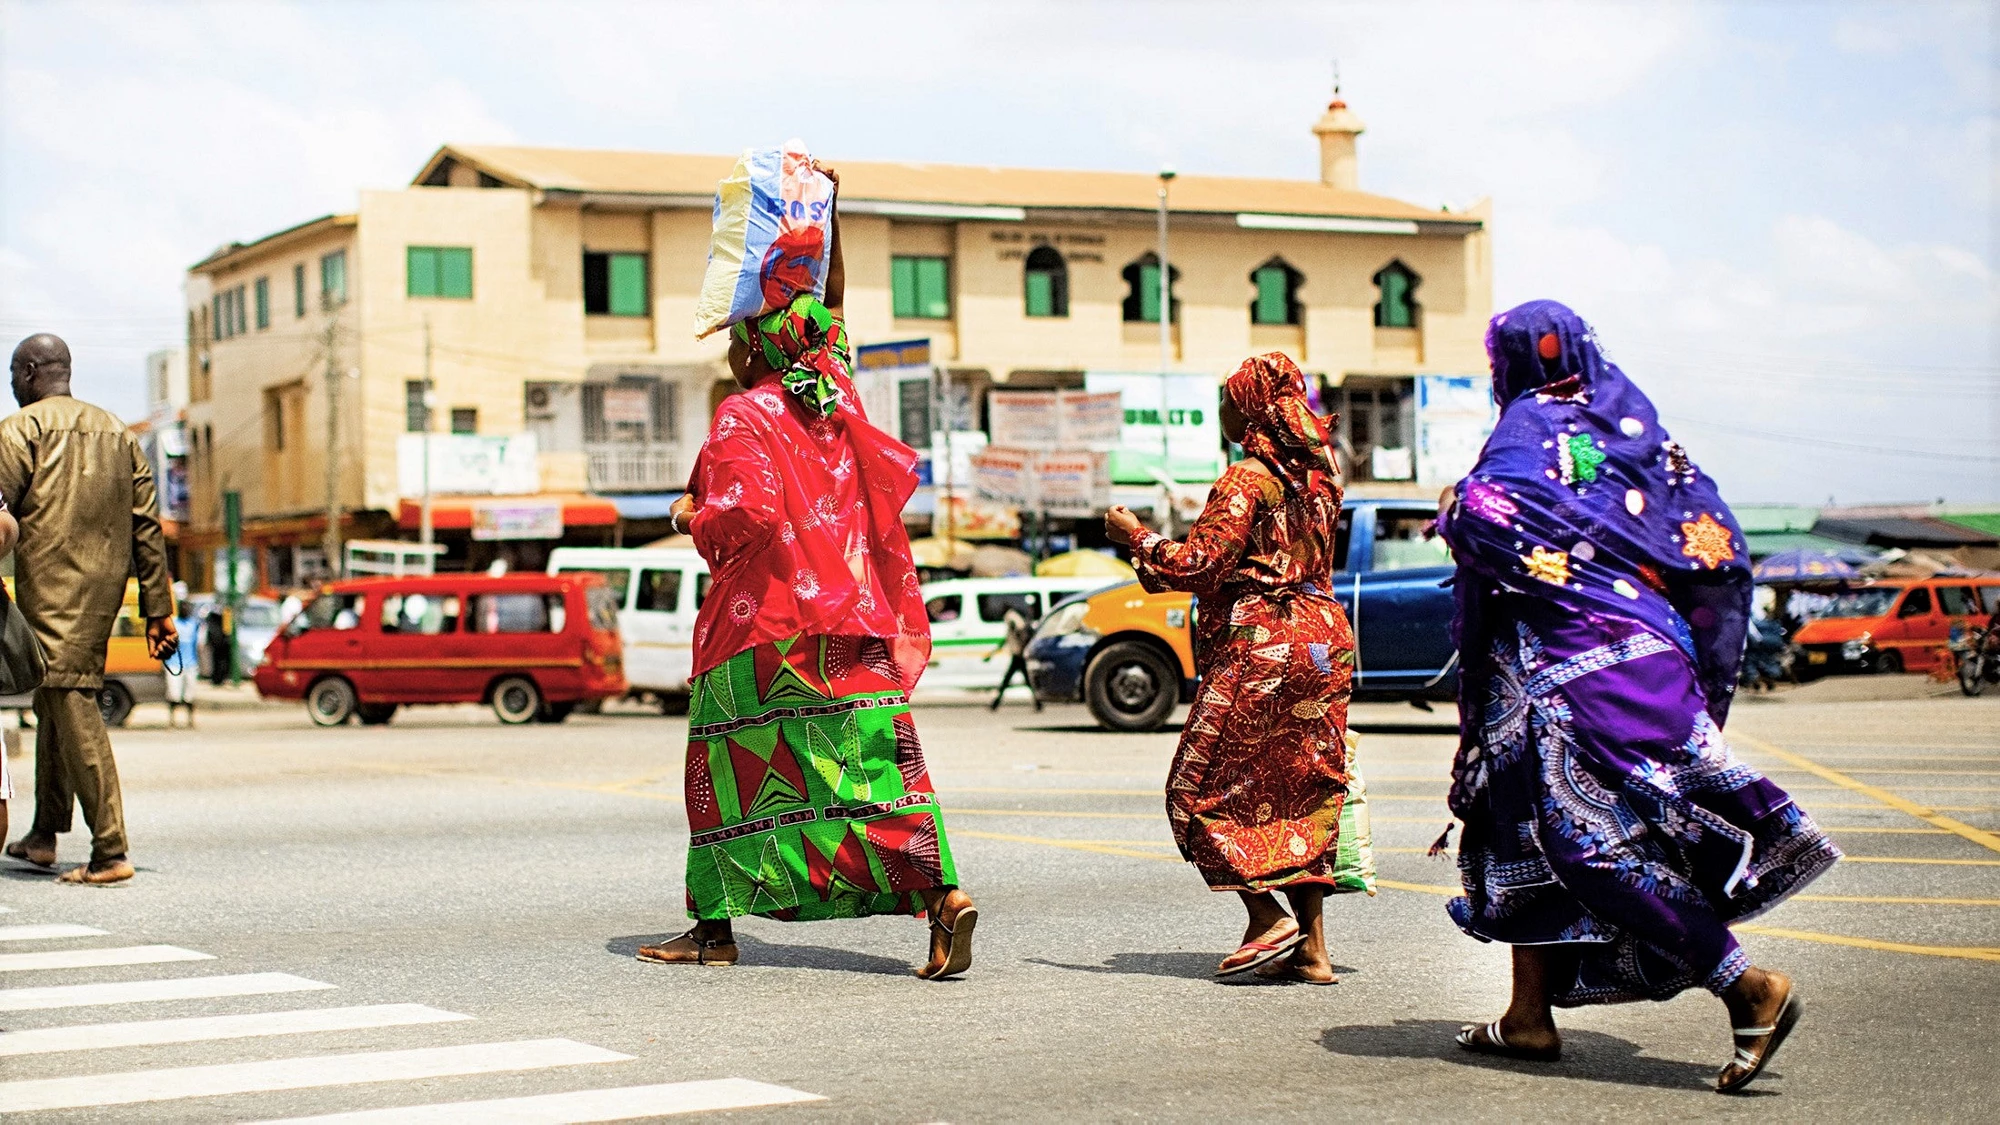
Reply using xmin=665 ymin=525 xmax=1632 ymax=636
xmin=0 ymin=680 xmax=2000 ymax=1123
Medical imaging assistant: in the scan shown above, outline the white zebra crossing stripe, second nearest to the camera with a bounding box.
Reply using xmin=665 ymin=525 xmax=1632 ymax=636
xmin=0 ymin=1039 xmax=632 ymax=1115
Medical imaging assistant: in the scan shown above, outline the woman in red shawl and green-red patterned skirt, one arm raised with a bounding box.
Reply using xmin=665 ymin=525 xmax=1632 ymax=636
xmin=638 ymin=170 xmax=978 ymax=981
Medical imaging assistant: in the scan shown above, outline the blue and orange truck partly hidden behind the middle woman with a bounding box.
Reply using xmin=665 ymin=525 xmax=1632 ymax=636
xmin=1028 ymin=498 xmax=1458 ymax=731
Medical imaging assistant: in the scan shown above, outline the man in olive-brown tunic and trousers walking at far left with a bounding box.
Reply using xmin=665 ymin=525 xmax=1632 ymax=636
xmin=0 ymin=334 xmax=176 ymax=883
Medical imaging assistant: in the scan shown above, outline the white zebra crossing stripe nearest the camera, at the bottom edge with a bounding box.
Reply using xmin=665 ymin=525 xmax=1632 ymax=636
xmin=248 ymin=1079 xmax=826 ymax=1125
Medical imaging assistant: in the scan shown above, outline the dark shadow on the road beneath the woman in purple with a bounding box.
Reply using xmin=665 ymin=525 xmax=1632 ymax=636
xmin=1320 ymin=1019 xmax=1780 ymax=1095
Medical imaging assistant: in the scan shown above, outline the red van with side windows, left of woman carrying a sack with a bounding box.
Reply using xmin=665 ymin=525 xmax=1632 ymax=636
xmin=256 ymin=575 xmax=626 ymax=727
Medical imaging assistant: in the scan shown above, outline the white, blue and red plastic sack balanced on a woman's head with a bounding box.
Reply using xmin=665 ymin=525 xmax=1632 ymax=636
xmin=694 ymin=140 xmax=834 ymax=338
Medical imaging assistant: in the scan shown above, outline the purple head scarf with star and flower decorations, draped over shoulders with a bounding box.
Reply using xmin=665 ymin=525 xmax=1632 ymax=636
xmin=1444 ymin=300 xmax=1750 ymax=723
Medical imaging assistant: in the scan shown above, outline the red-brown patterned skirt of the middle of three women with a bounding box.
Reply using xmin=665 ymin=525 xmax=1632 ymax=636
xmin=1166 ymin=593 xmax=1354 ymax=891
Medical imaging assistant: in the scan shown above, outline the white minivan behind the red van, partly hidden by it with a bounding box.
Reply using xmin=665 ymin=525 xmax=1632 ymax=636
xmin=548 ymin=546 xmax=708 ymax=713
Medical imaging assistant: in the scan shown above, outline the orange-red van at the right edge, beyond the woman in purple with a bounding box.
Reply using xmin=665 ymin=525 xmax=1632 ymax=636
xmin=1792 ymin=575 xmax=2000 ymax=679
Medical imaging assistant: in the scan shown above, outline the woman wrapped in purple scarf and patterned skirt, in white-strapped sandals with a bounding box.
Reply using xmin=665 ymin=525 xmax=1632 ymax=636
xmin=1438 ymin=300 xmax=1840 ymax=1091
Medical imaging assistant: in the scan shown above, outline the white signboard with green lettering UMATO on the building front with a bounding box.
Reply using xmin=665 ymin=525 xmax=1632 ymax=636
xmin=1084 ymin=370 xmax=1228 ymax=484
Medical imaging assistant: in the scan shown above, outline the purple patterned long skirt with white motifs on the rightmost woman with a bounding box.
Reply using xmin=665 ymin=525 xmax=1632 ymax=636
xmin=1448 ymin=595 xmax=1840 ymax=1007
